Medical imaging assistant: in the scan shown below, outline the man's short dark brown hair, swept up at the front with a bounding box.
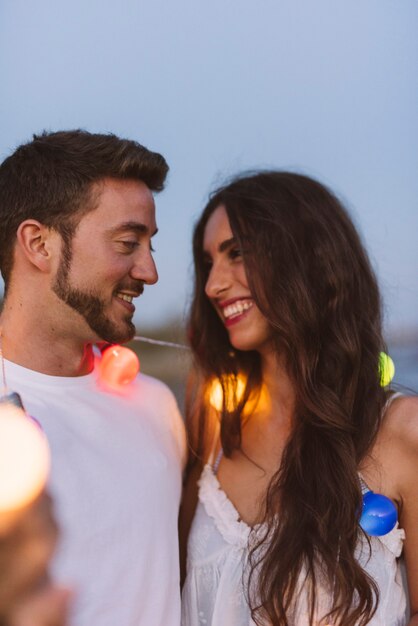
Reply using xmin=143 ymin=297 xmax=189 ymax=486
xmin=0 ymin=130 xmax=168 ymax=288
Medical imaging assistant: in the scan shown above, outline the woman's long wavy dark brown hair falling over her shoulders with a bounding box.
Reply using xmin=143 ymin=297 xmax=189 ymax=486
xmin=187 ymin=171 xmax=385 ymax=626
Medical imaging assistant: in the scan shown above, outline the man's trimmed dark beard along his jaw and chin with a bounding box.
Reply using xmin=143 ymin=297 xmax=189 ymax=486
xmin=52 ymin=240 xmax=136 ymax=343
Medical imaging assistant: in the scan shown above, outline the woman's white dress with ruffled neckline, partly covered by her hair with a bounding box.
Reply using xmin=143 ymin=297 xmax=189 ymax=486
xmin=182 ymin=454 xmax=406 ymax=626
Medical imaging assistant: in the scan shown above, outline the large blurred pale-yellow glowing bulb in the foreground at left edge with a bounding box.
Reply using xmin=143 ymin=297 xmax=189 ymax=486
xmin=0 ymin=403 xmax=50 ymax=513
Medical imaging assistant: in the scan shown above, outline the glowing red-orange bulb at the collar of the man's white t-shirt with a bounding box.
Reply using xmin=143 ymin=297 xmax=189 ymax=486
xmin=99 ymin=345 xmax=139 ymax=389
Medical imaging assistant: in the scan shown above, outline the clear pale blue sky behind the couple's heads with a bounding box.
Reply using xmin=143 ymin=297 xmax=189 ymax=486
xmin=0 ymin=0 xmax=418 ymax=329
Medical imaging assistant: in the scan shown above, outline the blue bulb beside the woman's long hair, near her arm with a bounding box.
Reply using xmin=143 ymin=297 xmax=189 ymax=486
xmin=360 ymin=491 xmax=398 ymax=537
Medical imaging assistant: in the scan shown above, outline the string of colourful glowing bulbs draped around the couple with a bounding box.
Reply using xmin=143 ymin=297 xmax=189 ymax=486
xmin=0 ymin=322 xmax=397 ymax=535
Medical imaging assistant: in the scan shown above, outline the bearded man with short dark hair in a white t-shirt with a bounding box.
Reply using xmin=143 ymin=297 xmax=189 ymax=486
xmin=0 ymin=131 xmax=184 ymax=626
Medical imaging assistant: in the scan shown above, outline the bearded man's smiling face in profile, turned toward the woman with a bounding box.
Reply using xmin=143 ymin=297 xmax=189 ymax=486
xmin=52 ymin=179 xmax=158 ymax=343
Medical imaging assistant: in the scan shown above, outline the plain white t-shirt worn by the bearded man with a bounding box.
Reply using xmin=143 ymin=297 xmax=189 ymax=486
xmin=5 ymin=361 xmax=185 ymax=626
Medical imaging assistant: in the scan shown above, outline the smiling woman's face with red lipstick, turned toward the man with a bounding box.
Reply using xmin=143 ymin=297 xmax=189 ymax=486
xmin=203 ymin=205 xmax=271 ymax=352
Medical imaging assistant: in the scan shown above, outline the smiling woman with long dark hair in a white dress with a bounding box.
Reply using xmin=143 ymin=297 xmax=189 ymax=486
xmin=183 ymin=172 xmax=418 ymax=626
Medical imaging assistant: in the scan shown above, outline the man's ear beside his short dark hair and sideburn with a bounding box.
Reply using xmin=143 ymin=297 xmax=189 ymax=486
xmin=16 ymin=220 xmax=59 ymax=272
